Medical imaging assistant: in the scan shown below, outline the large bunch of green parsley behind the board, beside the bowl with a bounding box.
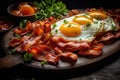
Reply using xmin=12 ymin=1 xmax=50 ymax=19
xmin=34 ymin=0 xmax=68 ymax=20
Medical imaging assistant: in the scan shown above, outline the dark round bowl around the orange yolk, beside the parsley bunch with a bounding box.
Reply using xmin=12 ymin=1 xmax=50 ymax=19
xmin=7 ymin=2 xmax=37 ymax=21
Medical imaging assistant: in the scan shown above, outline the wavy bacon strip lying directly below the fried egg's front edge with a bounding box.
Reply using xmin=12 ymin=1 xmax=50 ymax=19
xmin=52 ymin=37 xmax=90 ymax=52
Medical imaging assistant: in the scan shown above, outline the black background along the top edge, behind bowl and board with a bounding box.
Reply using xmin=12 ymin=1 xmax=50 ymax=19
xmin=0 ymin=0 xmax=120 ymax=15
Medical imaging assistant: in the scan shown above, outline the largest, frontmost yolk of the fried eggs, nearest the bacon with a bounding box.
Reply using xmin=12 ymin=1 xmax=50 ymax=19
xmin=60 ymin=22 xmax=81 ymax=37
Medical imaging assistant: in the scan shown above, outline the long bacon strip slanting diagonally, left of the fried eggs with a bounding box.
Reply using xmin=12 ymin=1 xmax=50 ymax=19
xmin=13 ymin=21 xmax=50 ymax=51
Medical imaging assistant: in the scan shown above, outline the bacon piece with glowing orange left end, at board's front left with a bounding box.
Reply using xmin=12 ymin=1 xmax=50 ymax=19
xmin=29 ymin=45 xmax=59 ymax=65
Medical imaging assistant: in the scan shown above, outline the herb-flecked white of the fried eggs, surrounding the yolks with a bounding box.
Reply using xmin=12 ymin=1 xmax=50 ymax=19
xmin=51 ymin=14 xmax=118 ymax=42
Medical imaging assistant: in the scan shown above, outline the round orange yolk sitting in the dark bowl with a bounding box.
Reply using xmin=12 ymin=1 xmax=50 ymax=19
xmin=20 ymin=5 xmax=35 ymax=15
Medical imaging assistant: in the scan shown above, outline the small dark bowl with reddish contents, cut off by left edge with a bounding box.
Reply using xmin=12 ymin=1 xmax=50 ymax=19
xmin=0 ymin=17 xmax=13 ymax=33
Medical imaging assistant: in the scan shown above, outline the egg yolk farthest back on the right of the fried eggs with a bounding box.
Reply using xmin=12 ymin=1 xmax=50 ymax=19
xmin=88 ymin=11 xmax=107 ymax=20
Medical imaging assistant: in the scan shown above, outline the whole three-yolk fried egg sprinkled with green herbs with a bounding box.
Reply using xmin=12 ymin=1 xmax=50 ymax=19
xmin=51 ymin=11 xmax=118 ymax=42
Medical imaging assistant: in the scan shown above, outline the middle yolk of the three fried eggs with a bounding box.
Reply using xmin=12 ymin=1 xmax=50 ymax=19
xmin=73 ymin=16 xmax=93 ymax=25
